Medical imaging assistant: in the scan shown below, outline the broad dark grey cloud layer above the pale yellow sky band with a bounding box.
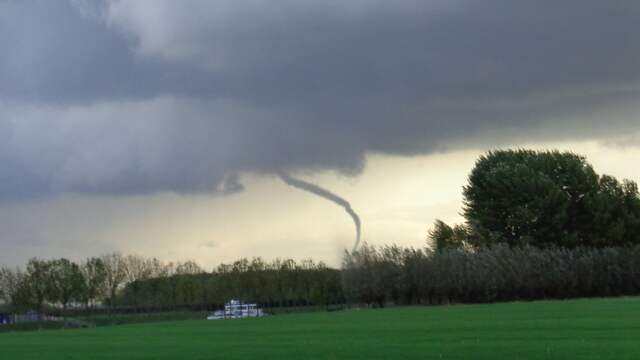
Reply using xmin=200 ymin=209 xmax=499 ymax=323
xmin=0 ymin=0 xmax=640 ymax=200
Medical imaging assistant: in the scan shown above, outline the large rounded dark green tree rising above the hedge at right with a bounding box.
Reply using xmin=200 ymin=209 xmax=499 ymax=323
xmin=464 ymin=150 xmax=640 ymax=247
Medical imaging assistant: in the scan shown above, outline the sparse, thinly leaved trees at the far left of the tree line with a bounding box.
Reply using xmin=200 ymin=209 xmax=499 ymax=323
xmin=0 ymin=253 xmax=211 ymax=311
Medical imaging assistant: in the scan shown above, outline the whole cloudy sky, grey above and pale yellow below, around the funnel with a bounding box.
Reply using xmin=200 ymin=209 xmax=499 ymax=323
xmin=0 ymin=0 xmax=640 ymax=267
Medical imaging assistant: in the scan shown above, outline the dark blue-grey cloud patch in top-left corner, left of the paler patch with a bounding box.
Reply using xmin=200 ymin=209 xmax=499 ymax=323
xmin=0 ymin=0 xmax=222 ymax=104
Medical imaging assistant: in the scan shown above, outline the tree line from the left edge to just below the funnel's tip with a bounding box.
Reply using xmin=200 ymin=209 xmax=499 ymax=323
xmin=0 ymin=254 xmax=344 ymax=312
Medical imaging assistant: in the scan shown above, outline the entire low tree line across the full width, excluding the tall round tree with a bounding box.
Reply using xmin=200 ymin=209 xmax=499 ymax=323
xmin=0 ymin=244 xmax=640 ymax=311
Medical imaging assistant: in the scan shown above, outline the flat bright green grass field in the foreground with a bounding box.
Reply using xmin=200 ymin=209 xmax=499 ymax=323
xmin=0 ymin=298 xmax=640 ymax=360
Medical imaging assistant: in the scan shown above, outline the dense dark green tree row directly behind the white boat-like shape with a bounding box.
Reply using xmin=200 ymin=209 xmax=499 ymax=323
xmin=120 ymin=258 xmax=344 ymax=308
